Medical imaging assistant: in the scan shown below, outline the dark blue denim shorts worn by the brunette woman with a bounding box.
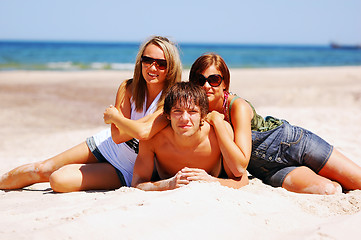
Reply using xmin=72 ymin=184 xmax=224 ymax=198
xmin=247 ymin=120 xmax=333 ymax=187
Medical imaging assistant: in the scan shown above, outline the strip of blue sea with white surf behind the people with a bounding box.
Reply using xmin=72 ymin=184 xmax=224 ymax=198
xmin=0 ymin=41 xmax=361 ymax=71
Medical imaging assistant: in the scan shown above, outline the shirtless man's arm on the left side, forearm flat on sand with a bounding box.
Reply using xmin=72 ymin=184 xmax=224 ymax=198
xmin=132 ymin=139 xmax=189 ymax=191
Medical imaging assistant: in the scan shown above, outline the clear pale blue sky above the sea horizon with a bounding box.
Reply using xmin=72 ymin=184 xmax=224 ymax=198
xmin=0 ymin=0 xmax=361 ymax=44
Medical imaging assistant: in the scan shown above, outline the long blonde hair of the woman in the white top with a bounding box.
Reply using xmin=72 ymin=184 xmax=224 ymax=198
xmin=132 ymin=36 xmax=182 ymax=111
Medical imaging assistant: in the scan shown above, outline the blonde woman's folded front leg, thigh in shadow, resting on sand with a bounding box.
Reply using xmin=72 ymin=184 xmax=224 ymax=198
xmin=50 ymin=163 xmax=121 ymax=192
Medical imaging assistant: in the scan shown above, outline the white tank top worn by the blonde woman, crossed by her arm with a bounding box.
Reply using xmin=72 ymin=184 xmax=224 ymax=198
xmin=93 ymin=92 xmax=162 ymax=186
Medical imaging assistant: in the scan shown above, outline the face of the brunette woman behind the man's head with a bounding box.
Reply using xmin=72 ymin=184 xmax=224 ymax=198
xmin=202 ymin=65 xmax=226 ymax=110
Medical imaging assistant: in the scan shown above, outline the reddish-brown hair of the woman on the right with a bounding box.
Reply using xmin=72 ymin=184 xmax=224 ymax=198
xmin=189 ymin=53 xmax=230 ymax=91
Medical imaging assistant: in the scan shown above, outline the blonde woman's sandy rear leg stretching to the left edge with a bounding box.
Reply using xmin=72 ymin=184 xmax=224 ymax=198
xmin=0 ymin=142 xmax=97 ymax=189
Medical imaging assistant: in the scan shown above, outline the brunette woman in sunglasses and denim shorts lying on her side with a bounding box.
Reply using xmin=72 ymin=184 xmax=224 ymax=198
xmin=189 ymin=54 xmax=361 ymax=194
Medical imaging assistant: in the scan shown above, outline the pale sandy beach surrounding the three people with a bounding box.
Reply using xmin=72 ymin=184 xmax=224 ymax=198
xmin=0 ymin=67 xmax=361 ymax=240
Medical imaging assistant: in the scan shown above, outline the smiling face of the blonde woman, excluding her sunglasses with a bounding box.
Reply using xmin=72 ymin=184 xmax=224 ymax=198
xmin=142 ymin=44 xmax=167 ymax=84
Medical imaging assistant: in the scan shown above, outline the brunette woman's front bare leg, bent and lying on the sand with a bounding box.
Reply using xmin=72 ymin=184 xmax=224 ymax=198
xmin=282 ymin=166 xmax=342 ymax=194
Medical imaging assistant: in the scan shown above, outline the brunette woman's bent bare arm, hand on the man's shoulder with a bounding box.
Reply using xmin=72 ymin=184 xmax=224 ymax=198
xmin=207 ymin=99 xmax=252 ymax=177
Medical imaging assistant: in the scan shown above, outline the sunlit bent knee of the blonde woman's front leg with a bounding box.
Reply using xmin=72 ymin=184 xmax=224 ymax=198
xmin=49 ymin=166 xmax=78 ymax=193
